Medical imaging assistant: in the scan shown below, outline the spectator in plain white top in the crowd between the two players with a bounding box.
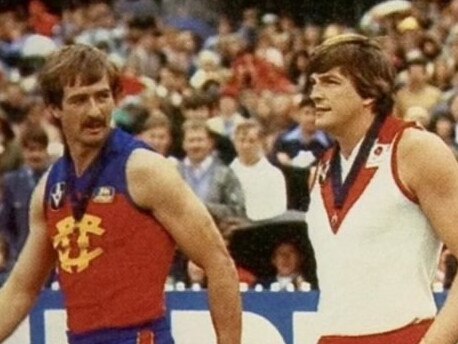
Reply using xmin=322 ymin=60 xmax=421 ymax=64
xmin=230 ymin=119 xmax=286 ymax=221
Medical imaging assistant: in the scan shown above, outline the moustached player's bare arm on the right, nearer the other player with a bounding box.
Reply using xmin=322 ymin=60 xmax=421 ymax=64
xmin=127 ymin=150 xmax=241 ymax=344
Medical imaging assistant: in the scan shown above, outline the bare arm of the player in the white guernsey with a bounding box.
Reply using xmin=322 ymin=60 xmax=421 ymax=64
xmin=398 ymin=130 xmax=458 ymax=344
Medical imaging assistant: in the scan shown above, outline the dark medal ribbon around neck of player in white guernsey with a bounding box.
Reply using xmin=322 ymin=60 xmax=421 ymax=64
xmin=330 ymin=116 xmax=385 ymax=209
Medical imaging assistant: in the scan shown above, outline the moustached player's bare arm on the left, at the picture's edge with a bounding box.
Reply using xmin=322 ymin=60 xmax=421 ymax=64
xmin=0 ymin=173 xmax=55 ymax=342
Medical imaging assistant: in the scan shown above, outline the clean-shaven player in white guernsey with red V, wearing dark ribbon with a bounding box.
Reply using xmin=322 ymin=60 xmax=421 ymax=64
xmin=307 ymin=34 xmax=458 ymax=344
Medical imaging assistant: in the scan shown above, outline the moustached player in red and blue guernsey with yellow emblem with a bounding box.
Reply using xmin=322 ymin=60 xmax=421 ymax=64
xmin=0 ymin=45 xmax=241 ymax=344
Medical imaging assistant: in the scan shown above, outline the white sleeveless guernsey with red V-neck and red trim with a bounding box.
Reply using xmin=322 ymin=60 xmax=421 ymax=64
xmin=307 ymin=117 xmax=441 ymax=335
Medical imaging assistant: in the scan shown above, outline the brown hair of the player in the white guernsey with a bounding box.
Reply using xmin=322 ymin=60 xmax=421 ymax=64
xmin=307 ymin=34 xmax=395 ymax=116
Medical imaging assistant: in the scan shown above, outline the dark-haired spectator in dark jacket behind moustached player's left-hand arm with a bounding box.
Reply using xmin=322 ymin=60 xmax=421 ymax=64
xmin=0 ymin=126 xmax=51 ymax=259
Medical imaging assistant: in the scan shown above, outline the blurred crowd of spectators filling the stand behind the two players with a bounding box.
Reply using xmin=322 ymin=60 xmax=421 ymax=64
xmin=0 ymin=0 xmax=458 ymax=290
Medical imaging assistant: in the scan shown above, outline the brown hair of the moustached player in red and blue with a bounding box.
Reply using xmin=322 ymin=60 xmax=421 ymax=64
xmin=38 ymin=44 xmax=121 ymax=107
